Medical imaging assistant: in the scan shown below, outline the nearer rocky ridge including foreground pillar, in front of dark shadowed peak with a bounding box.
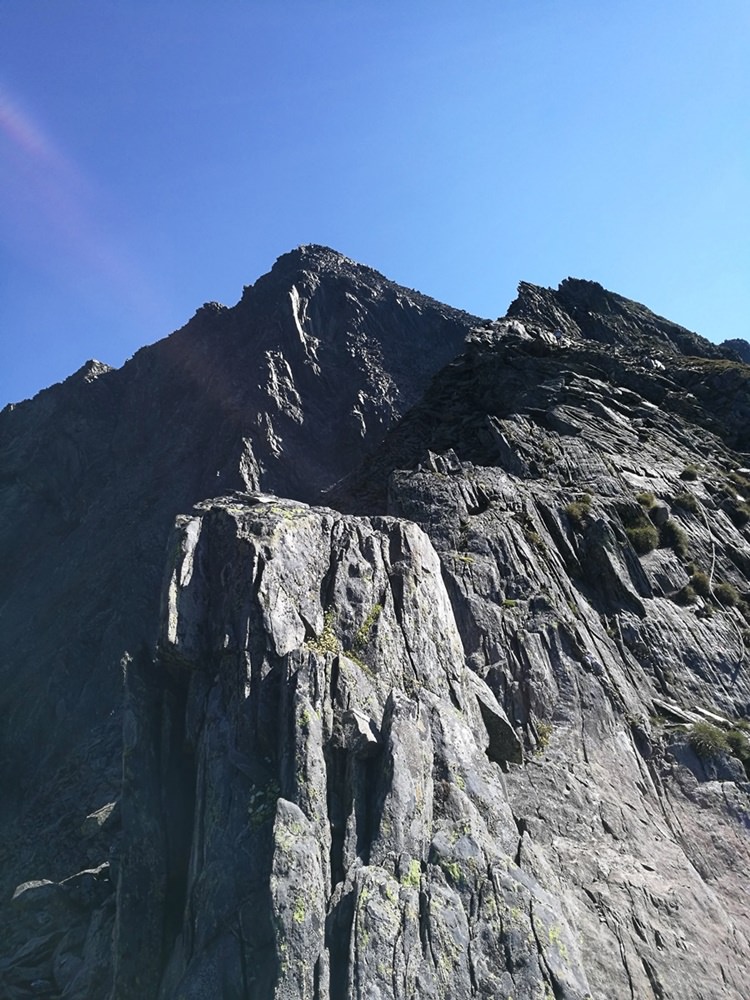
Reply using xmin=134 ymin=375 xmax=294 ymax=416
xmin=0 ymin=262 xmax=750 ymax=1000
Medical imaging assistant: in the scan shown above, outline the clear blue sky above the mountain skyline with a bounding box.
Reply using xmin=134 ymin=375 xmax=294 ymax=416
xmin=0 ymin=0 xmax=750 ymax=405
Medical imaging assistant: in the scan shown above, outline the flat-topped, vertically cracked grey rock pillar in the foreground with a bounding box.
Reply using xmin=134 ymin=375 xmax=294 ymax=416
xmin=114 ymin=498 xmax=590 ymax=998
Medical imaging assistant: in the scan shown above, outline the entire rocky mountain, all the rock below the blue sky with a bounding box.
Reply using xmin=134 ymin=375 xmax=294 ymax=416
xmin=0 ymin=246 xmax=750 ymax=1000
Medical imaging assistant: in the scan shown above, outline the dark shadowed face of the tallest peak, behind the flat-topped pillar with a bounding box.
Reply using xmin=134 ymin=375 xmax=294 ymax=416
xmin=0 ymin=246 xmax=475 ymax=916
